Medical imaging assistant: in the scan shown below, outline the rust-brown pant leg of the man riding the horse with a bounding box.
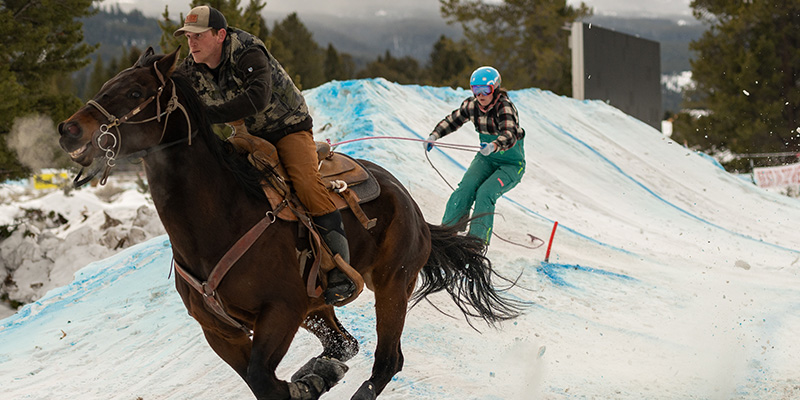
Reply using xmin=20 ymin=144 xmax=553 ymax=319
xmin=275 ymin=131 xmax=336 ymax=217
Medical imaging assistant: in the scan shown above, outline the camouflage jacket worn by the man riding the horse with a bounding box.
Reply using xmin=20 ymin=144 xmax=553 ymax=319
xmin=181 ymin=27 xmax=311 ymax=142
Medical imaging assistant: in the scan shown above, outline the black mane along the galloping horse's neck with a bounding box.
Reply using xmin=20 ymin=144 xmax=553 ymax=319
xmin=147 ymin=55 xmax=266 ymax=201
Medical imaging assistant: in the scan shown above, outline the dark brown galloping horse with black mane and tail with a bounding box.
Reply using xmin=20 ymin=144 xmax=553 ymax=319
xmin=58 ymin=49 xmax=521 ymax=400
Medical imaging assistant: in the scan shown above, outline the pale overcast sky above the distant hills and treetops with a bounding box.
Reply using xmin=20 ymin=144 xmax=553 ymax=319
xmin=109 ymin=0 xmax=691 ymax=18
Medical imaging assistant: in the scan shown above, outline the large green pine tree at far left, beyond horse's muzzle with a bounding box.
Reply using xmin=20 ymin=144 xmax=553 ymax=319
xmin=0 ymin=0 xmax=94 ymax=178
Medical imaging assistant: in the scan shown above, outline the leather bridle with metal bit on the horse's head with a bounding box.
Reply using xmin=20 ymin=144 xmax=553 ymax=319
xmin=73 ymin=61 xmax=194 ymax=188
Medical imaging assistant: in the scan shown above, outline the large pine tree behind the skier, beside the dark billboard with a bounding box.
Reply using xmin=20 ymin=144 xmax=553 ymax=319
xmin=439 ymin=0 xmax=591 ymax=95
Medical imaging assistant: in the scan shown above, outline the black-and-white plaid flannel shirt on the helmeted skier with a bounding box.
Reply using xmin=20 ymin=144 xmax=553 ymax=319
xmin=433 ymin=93 xmax=525 ymax=151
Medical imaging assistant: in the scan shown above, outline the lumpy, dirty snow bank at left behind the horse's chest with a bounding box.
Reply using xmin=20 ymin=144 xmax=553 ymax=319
xmin=0 ymin=174 xmax=165 ymax=318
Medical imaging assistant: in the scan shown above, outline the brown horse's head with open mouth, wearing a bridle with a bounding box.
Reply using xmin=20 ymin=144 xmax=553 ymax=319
xmin=58 ymin=48 xmax=183 ymax=167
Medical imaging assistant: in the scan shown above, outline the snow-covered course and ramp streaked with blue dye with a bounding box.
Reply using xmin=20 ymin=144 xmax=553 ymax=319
xmin=0 ymin=79 xmax=800 ymax=400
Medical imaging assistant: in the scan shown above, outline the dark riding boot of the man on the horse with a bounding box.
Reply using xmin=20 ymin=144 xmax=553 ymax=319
xmin=313 ymin=210 xmax=356 ymax=304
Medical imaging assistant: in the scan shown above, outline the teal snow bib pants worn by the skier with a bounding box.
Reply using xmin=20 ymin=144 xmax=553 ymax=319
xmin=442 ymin=137 xmax=525 ymax=244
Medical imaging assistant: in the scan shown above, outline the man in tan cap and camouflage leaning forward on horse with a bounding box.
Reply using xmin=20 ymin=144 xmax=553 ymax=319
xmin=174 ymin=6 xmax=356 ymax=304
